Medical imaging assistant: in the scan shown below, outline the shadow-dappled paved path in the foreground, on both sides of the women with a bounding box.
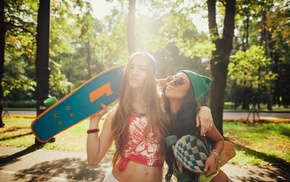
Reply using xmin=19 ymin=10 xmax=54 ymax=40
xmin=0 ymin=147 xmax=290 ymax=182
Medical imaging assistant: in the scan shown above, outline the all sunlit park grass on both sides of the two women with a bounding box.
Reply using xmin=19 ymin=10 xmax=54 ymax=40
xmin=0 ymin=116 xmax=290 ymax=167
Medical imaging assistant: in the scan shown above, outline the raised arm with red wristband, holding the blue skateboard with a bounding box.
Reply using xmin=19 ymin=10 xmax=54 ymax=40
xmin=87 ymin=104 xmax=114 ymax=166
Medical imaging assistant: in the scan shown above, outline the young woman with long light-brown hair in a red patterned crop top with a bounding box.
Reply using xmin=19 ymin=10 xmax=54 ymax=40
xmin=87 ymin=52 xmax=212 ymax=182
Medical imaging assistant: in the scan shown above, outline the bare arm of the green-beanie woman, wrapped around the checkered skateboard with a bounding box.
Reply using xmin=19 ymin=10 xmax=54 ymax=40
xmin=204 ymin=126 xmax=224 ymax=176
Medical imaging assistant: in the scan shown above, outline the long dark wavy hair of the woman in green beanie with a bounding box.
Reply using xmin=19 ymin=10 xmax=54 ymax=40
xmin=163 ymin=83 xmax=200 ymax=182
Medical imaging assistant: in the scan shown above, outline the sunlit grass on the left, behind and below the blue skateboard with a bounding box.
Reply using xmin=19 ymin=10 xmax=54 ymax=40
xmin=0 ymin=117 xmax=113 ymax=153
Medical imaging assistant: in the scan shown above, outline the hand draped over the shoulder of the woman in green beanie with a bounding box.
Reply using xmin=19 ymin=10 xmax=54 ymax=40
xmin=196 ymin=106 xmax=214 ymax=136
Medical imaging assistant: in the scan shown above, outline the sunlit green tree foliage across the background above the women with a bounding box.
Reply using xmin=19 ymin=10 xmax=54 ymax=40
xmin=2 ymin=0 xmax=290 ymax=120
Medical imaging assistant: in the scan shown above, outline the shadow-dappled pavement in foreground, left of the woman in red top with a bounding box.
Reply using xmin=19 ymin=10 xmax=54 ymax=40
xmin=0 ymin=147 xmax=111 ymax=182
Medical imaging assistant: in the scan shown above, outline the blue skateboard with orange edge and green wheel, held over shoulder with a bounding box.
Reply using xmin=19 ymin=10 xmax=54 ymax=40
xmin=31 ymin=64 xmax=125 ymax=143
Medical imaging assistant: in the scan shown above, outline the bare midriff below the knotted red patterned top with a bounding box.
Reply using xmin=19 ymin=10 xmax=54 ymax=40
xmin=113 ymin=160 xmax=163 ymax=182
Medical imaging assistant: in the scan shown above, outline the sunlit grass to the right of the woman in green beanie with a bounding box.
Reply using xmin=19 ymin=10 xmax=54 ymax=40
xmin=223 ymin=122 xmax=290 ymax=166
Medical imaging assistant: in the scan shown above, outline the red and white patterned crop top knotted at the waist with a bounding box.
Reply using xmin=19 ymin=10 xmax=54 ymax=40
xmin=119 ymin=113 xmax=164 ymax=171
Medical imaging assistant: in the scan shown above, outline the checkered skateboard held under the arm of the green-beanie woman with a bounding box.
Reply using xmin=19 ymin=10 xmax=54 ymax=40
xmin=165 ymin=135 xmax=236 ymax=182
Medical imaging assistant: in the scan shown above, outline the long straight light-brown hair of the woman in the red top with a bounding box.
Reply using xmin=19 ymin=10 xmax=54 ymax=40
xmin=112 ymin=52 xmax=167 ymax=166
